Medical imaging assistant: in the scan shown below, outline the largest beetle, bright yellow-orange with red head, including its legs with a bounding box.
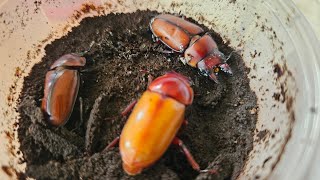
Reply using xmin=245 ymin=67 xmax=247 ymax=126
xmin=106 ymin=72 xmax=215 ymax=175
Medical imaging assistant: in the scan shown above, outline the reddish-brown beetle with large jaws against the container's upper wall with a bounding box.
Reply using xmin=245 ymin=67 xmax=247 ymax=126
xmin=149 ymin=14 xmax=232 ymax=83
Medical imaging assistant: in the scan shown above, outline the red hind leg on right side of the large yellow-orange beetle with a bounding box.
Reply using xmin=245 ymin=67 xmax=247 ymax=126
xmin=172 ymin=137 xmax=218 ymax=174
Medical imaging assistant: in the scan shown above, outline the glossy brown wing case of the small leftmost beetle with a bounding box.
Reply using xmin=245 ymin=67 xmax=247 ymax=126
xmin=42 ymin=69 xmax=80 ymax=126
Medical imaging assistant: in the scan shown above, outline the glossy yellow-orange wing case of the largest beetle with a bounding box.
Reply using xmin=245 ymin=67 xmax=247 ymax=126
xmin=120 ymin=91 xmax=185 ymax=175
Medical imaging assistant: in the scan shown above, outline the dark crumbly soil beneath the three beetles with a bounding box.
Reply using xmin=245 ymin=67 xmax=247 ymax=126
xmin=18 ymin=11 xmax=257 ymax=179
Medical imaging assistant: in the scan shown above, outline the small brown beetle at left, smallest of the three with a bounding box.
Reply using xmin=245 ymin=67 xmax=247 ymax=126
xmin=41 ymin=54 xmax=86 ymax=126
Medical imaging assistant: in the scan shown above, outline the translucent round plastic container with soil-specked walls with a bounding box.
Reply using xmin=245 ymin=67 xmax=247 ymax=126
xmin=0 ymin=0 xmax=320 ymax=180
